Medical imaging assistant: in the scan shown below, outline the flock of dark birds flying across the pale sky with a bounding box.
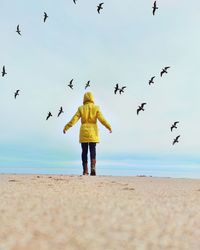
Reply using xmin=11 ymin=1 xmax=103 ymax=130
xmin=1 ymin=0 xmax=180 ymax=145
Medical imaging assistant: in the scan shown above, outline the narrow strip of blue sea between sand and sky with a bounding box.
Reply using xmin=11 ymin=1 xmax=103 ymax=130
xmin=0 ymin=164 xmax=200 ymax=179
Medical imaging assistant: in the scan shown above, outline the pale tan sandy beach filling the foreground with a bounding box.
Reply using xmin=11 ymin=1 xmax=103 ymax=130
xmin=0 ymin=174 xmax=200 ymax=250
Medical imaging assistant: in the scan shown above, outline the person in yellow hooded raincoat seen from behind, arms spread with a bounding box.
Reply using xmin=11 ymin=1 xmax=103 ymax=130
xmin=63 ymin=92 xmax=112 ymax=175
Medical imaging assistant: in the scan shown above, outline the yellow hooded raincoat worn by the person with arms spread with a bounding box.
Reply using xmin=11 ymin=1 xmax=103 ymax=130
xmin=63 ymin=92 xmax=112 ymax=143
